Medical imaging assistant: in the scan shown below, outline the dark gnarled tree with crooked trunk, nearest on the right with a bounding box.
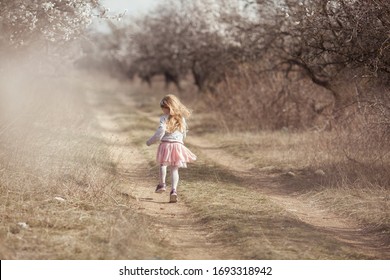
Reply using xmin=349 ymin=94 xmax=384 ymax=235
xmin=239 ymin=0 xmax=390 ymax=109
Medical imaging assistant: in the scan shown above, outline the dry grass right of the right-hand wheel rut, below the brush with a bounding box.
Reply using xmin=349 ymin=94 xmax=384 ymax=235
xmin=187 ymin=128 xmax=390 ymax=246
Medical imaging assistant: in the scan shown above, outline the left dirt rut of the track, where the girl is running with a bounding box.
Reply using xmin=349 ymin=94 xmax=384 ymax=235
xmin=87 ymin=88 xmax=225 ymax=260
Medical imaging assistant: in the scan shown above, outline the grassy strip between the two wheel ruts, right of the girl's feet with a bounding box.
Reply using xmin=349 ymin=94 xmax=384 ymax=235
xmin=182 ymin=163 xmax=365 ymax=259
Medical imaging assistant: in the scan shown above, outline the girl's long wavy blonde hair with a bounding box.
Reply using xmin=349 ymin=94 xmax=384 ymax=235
xmin=160 ymin=94 xmax=191 ymax=133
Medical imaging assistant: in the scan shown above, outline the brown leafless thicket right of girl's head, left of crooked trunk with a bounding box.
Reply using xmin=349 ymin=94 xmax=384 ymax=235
xmin=207 ymin=65 xmax=332 ymax=131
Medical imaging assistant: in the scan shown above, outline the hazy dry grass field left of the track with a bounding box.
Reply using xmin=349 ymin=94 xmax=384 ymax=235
xmin=0 ymin=71 xmax=171 ymax=259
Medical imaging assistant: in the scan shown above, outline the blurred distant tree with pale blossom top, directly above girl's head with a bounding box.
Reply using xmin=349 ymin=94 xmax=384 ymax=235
xmin=124 ymin=1 xmax=241 ymax=91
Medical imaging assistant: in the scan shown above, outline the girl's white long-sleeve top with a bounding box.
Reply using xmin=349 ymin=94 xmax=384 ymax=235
xmin=146 ymin=115 xmax=187 ymax=146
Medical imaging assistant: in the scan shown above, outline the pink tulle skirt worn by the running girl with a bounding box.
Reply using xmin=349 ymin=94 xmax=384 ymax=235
xmin=156 ymin=142 xmax=196 ymax=168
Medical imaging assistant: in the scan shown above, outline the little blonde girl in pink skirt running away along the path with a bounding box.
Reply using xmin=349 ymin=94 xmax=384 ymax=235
xmin=146 ymin=94 xmax=196 ymax=202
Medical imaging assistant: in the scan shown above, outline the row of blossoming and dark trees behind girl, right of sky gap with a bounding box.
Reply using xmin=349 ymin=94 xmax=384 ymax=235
xmin=78 ymin=0 xmax=390 ymax=128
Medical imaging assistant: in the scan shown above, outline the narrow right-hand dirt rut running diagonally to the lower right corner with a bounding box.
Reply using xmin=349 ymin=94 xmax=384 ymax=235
xmin=187 ymin=137 xmax=390 ymax=259
